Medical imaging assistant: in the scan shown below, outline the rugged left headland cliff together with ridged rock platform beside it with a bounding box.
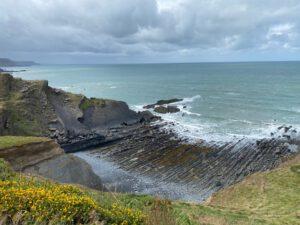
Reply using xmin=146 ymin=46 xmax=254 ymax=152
xmin=0 ymin=74 xmax=300 ymax=200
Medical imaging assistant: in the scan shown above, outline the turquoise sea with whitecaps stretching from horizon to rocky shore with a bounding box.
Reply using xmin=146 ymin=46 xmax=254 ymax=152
xmin=14 ymin=62 xmax=300 ymax=140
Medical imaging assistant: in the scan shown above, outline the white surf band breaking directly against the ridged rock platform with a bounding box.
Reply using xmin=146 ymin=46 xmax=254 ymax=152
xmin=156 ymin=114 xmax=300 ymax=145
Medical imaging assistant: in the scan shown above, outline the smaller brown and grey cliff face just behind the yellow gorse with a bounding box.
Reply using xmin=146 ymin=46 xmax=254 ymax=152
xmin=0 ymin=137 xmax=102 ymax=189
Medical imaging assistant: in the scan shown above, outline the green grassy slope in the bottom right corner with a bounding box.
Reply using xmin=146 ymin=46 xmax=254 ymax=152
xmin=209 ymin=156 xmax=300 ymax=225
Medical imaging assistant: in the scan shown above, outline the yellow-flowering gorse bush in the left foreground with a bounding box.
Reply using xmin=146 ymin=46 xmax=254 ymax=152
xmin=0 ymin=177 xmax=144 ymax=225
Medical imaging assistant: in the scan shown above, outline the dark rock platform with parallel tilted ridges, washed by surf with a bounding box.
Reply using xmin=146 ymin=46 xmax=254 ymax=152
xmin=86 ymin=124 xmax=300 ymax=200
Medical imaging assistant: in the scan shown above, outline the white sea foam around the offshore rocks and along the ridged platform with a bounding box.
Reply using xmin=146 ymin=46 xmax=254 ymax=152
xmin=132 ymin=95 xmax=300 ymax=144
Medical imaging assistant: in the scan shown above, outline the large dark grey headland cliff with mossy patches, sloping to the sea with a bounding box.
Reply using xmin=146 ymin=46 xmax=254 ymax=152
xmin=0 ymin=74 xmax=140 ymax=142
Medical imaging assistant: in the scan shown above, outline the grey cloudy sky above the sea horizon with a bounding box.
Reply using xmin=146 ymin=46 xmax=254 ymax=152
xmin=0 ymin=0 xmax=300 ymax=63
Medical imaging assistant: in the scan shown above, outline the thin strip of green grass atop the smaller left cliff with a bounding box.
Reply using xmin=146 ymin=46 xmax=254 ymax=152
xmin=0 ymin=136 xmax=49 ymax=149
